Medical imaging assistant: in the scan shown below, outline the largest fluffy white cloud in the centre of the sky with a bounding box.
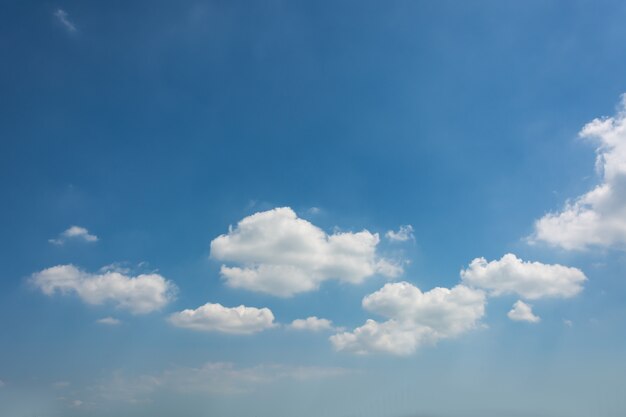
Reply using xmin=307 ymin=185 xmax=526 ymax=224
xmin=211 ymin=207 xmax=402 ymax=297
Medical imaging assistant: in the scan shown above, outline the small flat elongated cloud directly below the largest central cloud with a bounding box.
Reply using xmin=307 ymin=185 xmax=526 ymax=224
xmin=169 ymin=303 xmax=275 ymax=334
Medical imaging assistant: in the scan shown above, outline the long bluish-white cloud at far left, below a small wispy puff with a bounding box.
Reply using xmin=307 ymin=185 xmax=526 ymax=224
xmin=30 ymin=265 xmax=176 ymax=314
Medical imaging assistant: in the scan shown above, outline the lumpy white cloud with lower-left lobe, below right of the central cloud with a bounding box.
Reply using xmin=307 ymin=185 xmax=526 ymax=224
xmin=330 ymin=282 xmax=485 ymax=355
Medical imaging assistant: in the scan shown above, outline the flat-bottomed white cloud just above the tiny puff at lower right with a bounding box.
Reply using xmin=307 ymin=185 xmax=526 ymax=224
xmin=461 ymin=253 xmax=587 ymax=300
